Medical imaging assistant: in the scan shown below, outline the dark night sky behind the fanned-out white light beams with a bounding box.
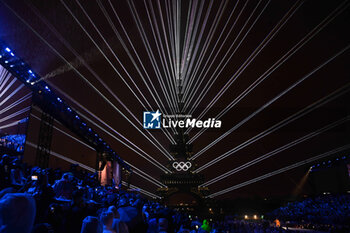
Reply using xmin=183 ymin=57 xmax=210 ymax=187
xmin=0 ymin=0 xmax=350 ymax=198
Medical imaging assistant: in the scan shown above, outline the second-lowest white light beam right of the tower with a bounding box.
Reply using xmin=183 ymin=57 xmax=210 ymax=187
xmin=200 ymin=116 xmax=350 ymax=187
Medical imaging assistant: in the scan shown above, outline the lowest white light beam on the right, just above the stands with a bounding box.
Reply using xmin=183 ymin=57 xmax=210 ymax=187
xmin=207 ymin=144 xmax=350 ymax=198
